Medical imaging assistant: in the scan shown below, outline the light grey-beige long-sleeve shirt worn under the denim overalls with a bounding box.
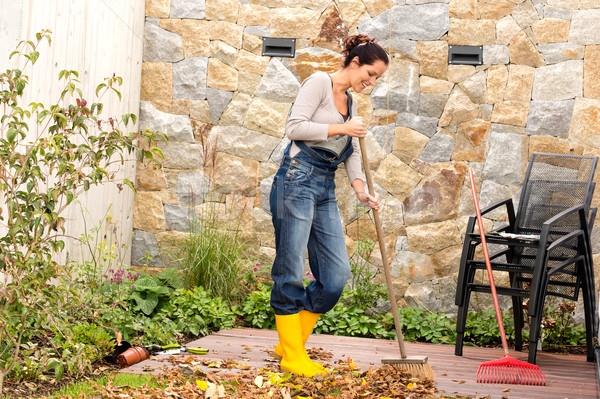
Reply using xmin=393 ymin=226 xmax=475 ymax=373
xmin=285 ymin=72 xmax=363 ymax=183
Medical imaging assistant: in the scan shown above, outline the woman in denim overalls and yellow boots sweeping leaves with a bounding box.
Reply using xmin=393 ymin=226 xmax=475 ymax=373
xmin=270 ymin=34 xmax=389 ymax=377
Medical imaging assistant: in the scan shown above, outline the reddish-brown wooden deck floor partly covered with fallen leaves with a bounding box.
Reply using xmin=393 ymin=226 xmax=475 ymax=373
xmin=122 ymin=328 xmax=599 ymax=399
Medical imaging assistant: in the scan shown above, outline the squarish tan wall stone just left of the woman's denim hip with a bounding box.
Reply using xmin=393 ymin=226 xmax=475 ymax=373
xmin=206 ymin=152 xmax=259 ymax=197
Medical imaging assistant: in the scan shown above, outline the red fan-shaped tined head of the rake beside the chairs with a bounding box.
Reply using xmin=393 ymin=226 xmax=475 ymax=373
xmin=477 ymin=355 xmax=546 ymax=385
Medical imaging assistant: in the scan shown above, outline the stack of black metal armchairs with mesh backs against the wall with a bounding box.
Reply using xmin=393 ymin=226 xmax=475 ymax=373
xmin=455 ymin=153 xmax=598 ymax=363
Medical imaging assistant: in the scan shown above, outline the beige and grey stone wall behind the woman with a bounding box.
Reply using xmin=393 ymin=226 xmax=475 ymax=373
xmin=132 ymin=0 xmax=600 ymax=312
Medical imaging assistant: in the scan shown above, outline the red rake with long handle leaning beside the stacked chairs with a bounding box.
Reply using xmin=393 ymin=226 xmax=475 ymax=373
xmin=469 ymin=168 xmax=546 ymax=385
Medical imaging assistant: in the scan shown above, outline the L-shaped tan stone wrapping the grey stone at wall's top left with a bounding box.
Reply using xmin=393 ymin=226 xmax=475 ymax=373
xmin=160 ymin=19 xmax=211 ymax=58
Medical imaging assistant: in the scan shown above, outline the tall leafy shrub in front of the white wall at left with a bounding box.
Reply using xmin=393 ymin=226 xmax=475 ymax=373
xmin=0 ymin=30 xmax=164 ymax=392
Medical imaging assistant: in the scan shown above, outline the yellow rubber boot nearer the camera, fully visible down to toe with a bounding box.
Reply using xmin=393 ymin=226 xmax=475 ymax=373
xmin=275 ymin=313 xmax=319 ymax=377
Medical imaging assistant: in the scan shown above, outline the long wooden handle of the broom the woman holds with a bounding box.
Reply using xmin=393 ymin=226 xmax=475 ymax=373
xmin=358 ymin=138 xmax=406 ymax=359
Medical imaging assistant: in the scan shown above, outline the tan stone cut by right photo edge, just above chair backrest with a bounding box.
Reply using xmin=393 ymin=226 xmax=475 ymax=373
xmin=569 ymin=98 xmax=600 ymax=148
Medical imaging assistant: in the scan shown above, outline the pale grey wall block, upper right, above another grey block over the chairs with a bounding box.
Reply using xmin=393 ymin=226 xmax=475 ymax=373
xmin=532 ymin=60 xmax=583 ymax=101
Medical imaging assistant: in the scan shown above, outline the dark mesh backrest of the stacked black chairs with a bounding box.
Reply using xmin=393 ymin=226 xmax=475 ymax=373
xmin=515 ymin=153 xmax=598 ymax=234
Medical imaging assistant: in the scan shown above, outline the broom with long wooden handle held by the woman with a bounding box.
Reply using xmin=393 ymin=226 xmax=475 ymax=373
xmin=359 ymin=138 xmax=434 ymax=380
